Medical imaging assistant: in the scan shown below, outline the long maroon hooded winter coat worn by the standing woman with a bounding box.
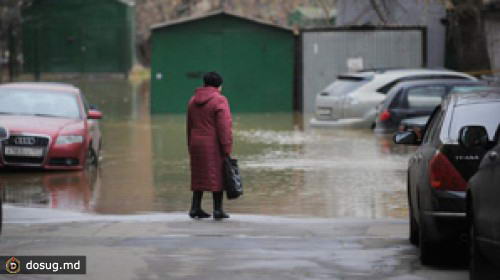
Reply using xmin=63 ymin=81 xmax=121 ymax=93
xmin=187 ymin=87 xmax=233 ymax=192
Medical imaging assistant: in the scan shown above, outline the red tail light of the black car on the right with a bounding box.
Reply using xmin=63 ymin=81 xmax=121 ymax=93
xmin=429 ymin=152 xmax=467 ymax=191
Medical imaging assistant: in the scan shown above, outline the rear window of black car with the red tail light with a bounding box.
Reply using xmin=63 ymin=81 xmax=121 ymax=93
xmin=450 ymin=102 xmax=500 ymax=141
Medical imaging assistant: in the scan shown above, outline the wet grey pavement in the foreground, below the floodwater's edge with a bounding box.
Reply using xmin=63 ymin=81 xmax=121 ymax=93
xmin=0 ymin=206 xmax=468 ymax=280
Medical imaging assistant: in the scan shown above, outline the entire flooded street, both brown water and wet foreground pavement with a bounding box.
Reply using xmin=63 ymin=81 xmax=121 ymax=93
xmin=0 ymin=81 xmax=467 ymax=280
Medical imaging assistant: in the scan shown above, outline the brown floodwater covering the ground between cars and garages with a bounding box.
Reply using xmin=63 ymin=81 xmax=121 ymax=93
xmin=0 ymin=80 xmax=414 ymax=218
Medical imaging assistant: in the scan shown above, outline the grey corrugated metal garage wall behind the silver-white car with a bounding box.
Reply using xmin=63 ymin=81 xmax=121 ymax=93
xmin=302 ymin=28 xmax=425 ymax=114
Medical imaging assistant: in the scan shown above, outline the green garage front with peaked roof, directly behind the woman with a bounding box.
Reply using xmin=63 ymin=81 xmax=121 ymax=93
xmin=151 ymin=15 xmax=295 ymax=113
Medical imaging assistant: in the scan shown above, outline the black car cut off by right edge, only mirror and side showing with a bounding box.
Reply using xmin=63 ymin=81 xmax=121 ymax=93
xmin=460 ymin=130 xmax=500 ymax=280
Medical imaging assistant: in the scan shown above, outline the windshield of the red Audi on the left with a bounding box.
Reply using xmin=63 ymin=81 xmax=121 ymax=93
xmin=0 ymin=89 xmax=80 ymax=119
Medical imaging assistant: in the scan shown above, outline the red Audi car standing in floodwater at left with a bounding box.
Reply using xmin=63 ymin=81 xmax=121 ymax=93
xmin=0 ymin=83 xmax=102 ymax=170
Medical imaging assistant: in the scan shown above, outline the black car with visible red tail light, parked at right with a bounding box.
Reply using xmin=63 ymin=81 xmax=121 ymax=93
xmin=394 ymin=90 xmax=500 ymax=264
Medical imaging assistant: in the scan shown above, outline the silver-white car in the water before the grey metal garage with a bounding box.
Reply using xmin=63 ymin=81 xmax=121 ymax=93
xmin=311 ymin=69 xmax=476 ymax=128
